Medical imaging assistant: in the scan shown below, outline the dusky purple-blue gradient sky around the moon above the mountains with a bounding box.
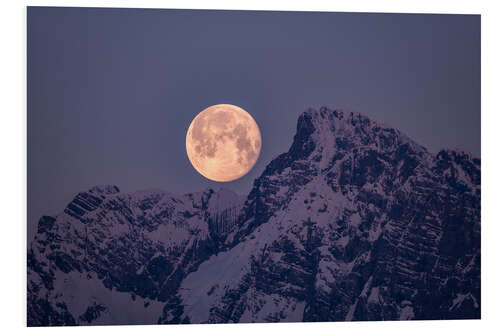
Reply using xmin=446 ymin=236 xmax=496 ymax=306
xmin=27 ymin=7 xmax=480 ymax=239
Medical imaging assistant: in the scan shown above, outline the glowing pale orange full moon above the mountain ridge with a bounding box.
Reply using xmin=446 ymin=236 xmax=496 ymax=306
xmin=186 ymin=104 xmax=262 ymax=182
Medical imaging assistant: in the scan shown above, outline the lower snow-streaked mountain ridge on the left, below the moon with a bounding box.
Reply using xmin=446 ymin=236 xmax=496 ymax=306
xmin=28 ymin=186 xmax=244 ymax=325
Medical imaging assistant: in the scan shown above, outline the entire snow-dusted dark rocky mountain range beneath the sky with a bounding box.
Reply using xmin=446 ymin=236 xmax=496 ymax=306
xmin=28 ymin=108 xmax=481 ymax=326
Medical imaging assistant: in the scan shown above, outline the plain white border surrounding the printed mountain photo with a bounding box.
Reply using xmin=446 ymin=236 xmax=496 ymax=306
xmin=0 ymin=0 xmax=500 ymax=333
